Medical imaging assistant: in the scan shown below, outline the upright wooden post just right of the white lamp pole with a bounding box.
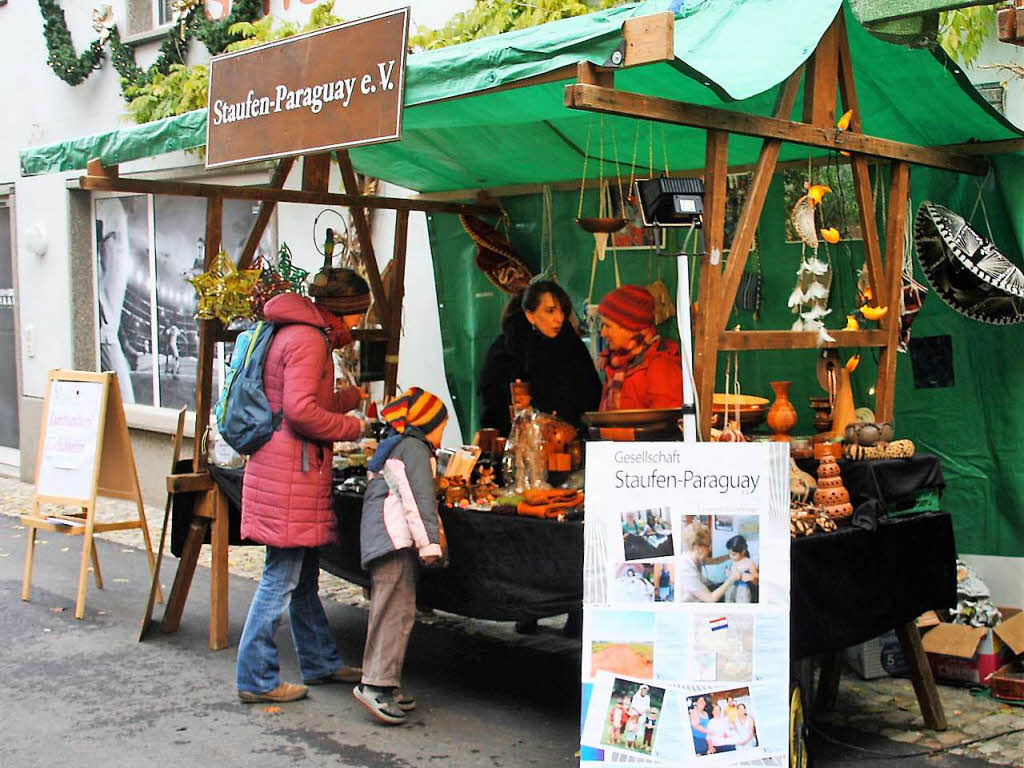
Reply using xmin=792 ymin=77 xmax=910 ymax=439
xmin=692 ymin=131 xmax=729 ymax=440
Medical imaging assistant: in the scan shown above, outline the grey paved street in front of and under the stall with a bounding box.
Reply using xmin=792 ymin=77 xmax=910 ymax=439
xmin=0 ymin=478 xmax=1024 ymax=768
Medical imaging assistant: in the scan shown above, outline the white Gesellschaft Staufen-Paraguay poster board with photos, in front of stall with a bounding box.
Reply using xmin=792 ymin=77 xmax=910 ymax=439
xmin=580 ymin=442 xmax=790 ymax=767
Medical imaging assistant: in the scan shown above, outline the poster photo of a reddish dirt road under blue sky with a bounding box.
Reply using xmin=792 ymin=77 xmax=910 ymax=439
xmin=584 ymin=609 xmax=654 ymax=679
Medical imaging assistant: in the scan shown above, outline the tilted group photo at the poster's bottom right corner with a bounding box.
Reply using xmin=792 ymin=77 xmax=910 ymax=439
xmin=686 ymin=687 xmax=759 ymax=757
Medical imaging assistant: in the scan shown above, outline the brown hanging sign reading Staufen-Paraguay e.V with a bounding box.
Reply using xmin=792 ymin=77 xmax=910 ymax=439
xmin=206 ymin=8 xmax=409 ymax=168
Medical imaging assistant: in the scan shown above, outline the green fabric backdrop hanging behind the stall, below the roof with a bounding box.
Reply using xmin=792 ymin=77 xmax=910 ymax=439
xmin=429 ymin=167 xmax=1024 ymax=556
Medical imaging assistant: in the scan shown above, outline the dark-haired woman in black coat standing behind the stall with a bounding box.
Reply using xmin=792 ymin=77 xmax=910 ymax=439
xmin=479 ymin=281 xmax=601 ymax=435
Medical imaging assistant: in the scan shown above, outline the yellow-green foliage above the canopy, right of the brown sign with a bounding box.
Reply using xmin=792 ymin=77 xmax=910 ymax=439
xmin=409 ymin=0 xmax=633 ymax=50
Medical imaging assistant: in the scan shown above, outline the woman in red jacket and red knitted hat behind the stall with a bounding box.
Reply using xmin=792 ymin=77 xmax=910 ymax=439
xmin=598 ymin=286 xmax=683 ymax=411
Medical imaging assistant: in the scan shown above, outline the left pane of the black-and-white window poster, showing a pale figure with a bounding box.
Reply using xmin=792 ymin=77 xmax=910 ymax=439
xmin=95 ymin=195 xmax=155 ymax=406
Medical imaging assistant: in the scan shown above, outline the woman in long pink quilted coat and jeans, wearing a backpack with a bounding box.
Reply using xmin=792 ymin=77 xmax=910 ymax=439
xmin=237 ymin=269 xmax=370 ymax=702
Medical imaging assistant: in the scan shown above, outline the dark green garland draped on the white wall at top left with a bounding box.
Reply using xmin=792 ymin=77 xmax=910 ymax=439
xmin=39 ymin=0 xmax=263 ymax=99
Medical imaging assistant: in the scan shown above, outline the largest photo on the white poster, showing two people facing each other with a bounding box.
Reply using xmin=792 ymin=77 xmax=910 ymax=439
xmin=676 ymin=515 xmax=761 ymax=603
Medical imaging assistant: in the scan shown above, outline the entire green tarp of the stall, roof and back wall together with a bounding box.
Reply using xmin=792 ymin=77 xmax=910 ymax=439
xmin=20 ymin=0 xmax=1024 ymax=561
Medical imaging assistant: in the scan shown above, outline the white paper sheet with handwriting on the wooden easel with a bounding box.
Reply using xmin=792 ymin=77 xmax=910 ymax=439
xmin=36 ymin=381 xmax=103 ymax=500
